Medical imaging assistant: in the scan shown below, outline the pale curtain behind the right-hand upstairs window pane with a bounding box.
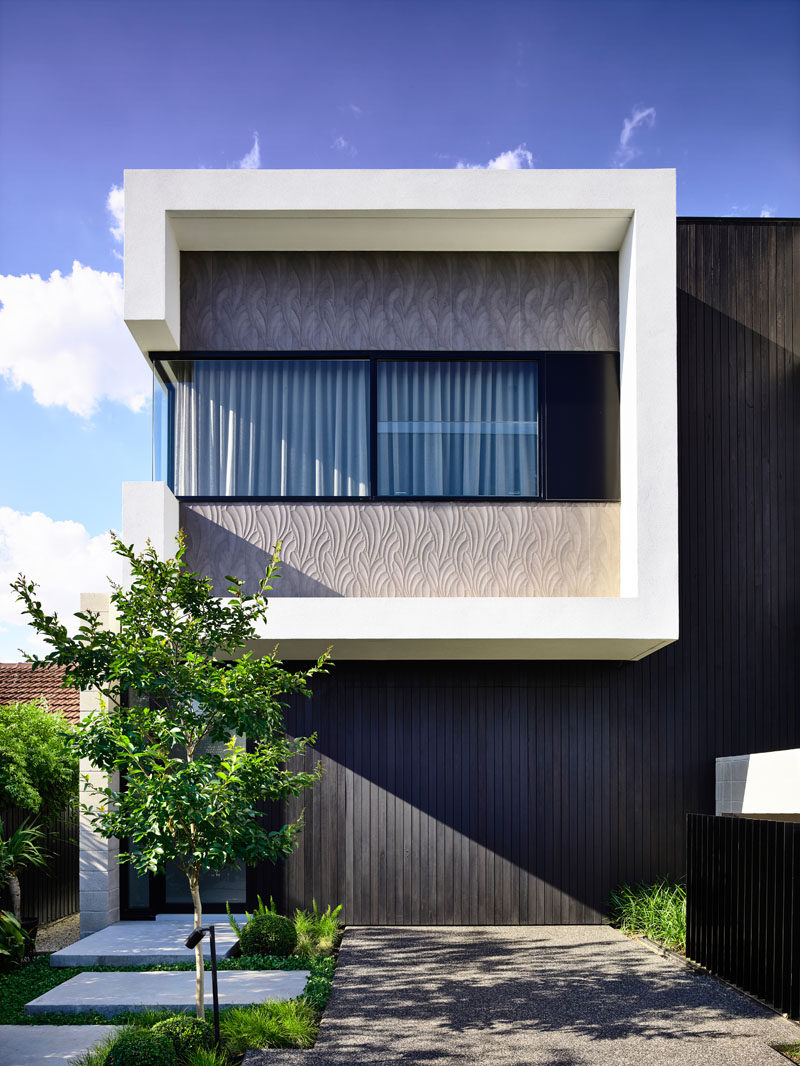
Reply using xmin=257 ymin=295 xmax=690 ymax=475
xmin=378 ymin=359 xmax=539 ymax=497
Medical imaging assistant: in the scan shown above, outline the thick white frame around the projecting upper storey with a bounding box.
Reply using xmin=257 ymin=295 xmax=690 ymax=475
xmin=125 ymin=171 xmax=678 ymax=660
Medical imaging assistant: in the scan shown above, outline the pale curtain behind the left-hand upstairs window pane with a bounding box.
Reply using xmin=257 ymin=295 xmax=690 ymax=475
xmin=172 ymin=359 xmax=369 ymax=496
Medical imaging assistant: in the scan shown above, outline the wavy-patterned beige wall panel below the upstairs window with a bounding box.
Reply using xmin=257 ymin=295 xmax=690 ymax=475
xmin=180 ymin=502 xmax=620 ymax=596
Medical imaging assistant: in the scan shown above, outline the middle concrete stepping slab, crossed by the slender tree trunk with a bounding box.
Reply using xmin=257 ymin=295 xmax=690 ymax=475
xmin=25 ymin=970 xmax=308 ymax=1018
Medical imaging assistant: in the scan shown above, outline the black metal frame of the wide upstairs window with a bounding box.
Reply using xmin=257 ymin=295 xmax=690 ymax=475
xmin=149 ymin=350 xmax=620 ymax=505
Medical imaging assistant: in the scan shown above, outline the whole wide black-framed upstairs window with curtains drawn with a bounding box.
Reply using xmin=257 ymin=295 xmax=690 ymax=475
xmin=154 ymin=353 xmax=619 ymax=500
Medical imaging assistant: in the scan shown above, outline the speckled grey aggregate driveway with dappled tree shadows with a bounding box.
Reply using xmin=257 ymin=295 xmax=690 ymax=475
xmin=243 ymin=925 xmax=800 ymax=1066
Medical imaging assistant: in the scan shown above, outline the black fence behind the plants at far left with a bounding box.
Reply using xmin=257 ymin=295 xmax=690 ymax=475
xmin=0 ymin=807 xmax=79 ymax=922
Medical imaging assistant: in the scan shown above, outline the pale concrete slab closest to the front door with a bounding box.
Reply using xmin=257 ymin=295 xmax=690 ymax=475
xmin=50 ymin=915 xmax=237 ymax=966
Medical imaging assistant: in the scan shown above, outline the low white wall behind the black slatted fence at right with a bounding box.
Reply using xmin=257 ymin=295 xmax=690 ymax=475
xmin=717 ymin=747 xmax=800 ymax=821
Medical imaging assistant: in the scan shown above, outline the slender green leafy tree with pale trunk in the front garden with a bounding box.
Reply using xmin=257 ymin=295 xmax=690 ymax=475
xmin=12 ymin=534 xmax=329 ymax=1018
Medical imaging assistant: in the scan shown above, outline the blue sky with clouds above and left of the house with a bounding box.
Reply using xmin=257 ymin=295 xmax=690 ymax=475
xmin=0 ymin=0 xmax=800 ymax=661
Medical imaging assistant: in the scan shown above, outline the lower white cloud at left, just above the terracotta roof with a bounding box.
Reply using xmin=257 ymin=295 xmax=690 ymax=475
xmin=0 ymin=507 xmax=122 ymax=662
